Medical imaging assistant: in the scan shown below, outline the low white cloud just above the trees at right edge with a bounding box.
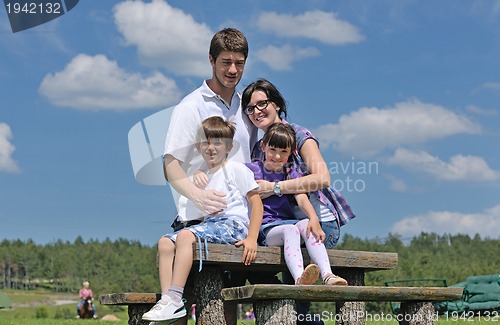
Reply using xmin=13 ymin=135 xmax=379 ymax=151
xmin=391 ymin=205 xmax=500 ymax=239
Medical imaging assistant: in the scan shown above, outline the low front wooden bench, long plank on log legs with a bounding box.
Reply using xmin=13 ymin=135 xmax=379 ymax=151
xmin=221 ymin=284 xmax=463 ymax=325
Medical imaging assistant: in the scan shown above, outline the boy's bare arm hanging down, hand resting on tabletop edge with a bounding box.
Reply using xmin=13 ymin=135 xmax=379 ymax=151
xmin=235 ymin=190 xmax=264 ymax=265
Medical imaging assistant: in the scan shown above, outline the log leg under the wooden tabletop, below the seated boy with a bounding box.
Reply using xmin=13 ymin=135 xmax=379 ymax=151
xmin=194 ymin=265 xmax=226 ymax=325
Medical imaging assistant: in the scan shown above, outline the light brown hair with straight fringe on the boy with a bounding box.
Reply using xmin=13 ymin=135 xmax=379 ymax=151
xmin=196 ymin=116 xmax=236 ymax=146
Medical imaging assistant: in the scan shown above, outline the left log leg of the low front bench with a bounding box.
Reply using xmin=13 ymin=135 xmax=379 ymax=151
xmin=254 ymin=299 xmax=297 ymax=325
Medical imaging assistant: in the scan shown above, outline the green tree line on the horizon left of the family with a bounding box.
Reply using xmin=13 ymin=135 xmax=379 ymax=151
xmin=0 ymin=237 xmax=159 ymax=296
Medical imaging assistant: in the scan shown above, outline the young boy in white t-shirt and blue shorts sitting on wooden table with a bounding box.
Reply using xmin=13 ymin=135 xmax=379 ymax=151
xmin=142 ymin=116 xmax=263 ymax=324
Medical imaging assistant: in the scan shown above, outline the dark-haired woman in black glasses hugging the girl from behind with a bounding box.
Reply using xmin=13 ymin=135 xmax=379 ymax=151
xmin=241 ymin=79 xmax=355 ymax=248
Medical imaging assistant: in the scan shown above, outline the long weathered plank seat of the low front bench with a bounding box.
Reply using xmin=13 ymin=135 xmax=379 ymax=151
xmin=221 ymin=284 xmax=463 ymax=302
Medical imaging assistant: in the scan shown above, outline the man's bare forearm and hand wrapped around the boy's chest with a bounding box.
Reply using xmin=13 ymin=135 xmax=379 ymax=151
xmin=163 ymin=154 xmax=226 ymax=215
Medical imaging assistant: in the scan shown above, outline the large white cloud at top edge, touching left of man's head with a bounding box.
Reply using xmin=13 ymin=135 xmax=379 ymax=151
xmin=114 ymin=0 xmax=214 ymax=77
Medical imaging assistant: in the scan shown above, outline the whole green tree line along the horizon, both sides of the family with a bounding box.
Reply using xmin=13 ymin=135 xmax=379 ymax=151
xmin=0 ymin=233 xmax=500 ymax=295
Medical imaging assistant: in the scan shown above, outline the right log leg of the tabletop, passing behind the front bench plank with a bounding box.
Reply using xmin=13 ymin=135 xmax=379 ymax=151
xmin=335 ymin=270 xmax=365 ymax=325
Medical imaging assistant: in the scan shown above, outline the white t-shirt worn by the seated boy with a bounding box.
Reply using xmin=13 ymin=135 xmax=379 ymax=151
xmin=186 ymin=160 xmax=259 ymax=227
